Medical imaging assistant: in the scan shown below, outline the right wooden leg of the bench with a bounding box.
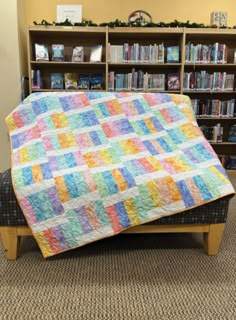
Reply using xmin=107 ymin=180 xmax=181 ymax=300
xmin=203 ymin=223 xmax=225 ymax=256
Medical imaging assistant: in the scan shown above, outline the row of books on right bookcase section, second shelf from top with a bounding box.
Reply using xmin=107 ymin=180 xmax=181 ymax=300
xmin=183 ymin=71 xmax=234 ymax=91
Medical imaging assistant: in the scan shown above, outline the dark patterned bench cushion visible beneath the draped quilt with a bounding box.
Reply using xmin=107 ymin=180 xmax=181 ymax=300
xmin=0 ymin=169 xmax=230 ymax=226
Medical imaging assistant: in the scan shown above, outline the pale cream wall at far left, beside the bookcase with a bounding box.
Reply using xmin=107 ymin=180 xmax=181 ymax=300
xmin=0 ymin=0 xmax=21 ymax=172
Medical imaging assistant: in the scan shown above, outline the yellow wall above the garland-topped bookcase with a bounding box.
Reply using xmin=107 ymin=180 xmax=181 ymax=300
xmin=25 ymin=0 xmax=236 ymax=26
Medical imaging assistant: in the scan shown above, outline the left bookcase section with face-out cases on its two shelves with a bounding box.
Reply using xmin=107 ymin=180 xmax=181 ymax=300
xmin=28 ymin=26 xmax=107 ymax=92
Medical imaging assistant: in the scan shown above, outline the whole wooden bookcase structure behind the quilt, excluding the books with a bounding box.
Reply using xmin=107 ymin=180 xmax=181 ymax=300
xmin=28 ymin=26 xmax=236 ymax=162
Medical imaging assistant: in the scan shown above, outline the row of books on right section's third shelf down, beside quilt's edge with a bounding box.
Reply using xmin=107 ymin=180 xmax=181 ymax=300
xmin=191 ymin=99 xmax=236 ymax=117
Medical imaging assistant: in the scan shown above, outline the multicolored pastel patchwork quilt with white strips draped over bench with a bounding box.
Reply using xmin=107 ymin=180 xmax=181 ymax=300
xmin=6 ymin=92 xmax=234 ymax=257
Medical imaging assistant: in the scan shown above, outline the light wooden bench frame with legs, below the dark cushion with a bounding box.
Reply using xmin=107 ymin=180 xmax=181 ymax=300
xmin=0 ymin=223 xmax=225 ymax=260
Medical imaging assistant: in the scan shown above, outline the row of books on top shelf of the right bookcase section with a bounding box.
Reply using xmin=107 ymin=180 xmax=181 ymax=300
xmin=185 ymin=42 xmax=228 ymax=64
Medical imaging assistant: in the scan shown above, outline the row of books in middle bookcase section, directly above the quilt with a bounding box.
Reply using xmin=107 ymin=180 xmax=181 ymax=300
xmin=108 ymin=69 xmax=180 ymax=91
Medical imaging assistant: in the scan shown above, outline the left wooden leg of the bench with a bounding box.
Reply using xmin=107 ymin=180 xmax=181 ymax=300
xmin=0 ymin=227 xmax=21 ymax=260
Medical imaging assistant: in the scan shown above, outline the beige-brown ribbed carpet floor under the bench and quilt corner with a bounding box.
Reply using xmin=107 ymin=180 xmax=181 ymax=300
xmin=0 ymin=174 xmax=236 ymax=320
